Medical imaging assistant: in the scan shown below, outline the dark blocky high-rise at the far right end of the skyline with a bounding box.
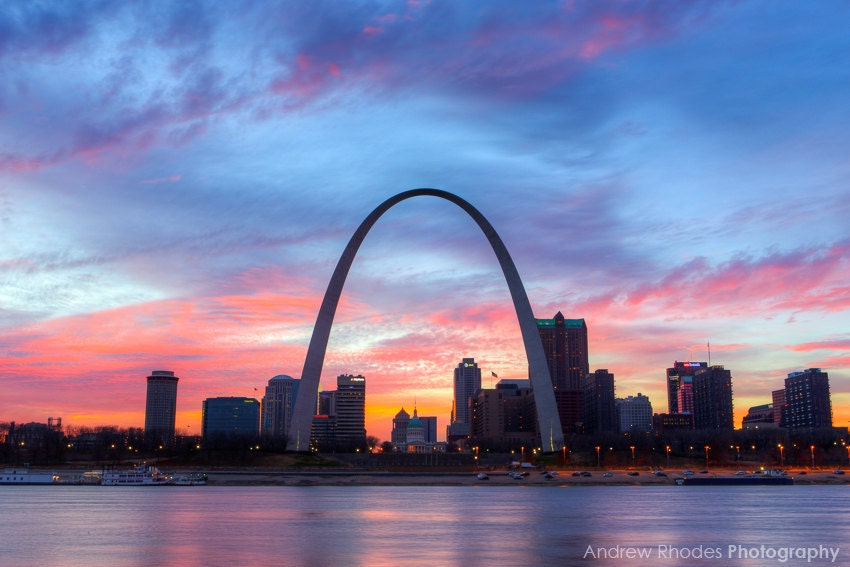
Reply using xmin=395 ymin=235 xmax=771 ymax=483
xmin=784 ymin=368 xmax=832 ymax=429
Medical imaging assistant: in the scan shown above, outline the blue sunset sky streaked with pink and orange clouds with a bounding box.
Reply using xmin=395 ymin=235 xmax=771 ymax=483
xmin=0 ymin=0 xmax=850 ymax=440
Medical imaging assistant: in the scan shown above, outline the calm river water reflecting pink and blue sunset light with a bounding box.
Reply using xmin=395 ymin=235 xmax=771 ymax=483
xmin=0 ymin=485 xmax=850 ymax=567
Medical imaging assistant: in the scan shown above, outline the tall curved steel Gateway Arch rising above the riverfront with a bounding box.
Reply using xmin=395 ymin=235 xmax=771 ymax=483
xmin=287 ymin=189 xmax=564 ymax=452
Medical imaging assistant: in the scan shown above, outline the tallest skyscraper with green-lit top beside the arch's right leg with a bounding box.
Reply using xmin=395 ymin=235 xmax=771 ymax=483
xmin=537 ymin=311 xmax=590 ymax=391
